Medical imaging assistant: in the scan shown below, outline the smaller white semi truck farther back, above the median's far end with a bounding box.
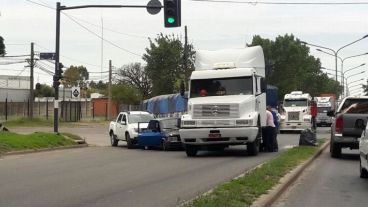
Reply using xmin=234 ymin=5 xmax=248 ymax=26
xmin=280 ymin=91 xmax=312 ymax=133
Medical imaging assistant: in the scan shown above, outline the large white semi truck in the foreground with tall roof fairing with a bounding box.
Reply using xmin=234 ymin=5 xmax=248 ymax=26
xmin=179 ymin=46 xmax=266 ymax=157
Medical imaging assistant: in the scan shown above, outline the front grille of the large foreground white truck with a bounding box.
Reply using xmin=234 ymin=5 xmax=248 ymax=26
xmin=193 ymin=104 xmax=239 ymax=118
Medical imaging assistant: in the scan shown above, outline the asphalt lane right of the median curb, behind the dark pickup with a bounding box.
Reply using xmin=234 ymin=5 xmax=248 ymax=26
xmin=274 ymin=126 xmax=368 ymax=207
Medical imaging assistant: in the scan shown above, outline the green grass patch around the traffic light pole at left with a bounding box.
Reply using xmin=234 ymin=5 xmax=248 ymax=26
xmin=0 ymin=132 xmax=75 ymax=155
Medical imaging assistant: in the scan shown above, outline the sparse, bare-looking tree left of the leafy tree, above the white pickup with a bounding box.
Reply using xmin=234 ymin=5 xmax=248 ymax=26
xmin=118 ymin=63 xmax=152 ymax=99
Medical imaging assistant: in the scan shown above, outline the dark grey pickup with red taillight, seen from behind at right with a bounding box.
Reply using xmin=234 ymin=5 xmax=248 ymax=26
xmin=328 ymin=96 xmax=368 ymax=157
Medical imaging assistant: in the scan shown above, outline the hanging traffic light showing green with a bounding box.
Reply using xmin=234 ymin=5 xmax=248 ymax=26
xmin=164 ymin=0 xmax=181 ymax=27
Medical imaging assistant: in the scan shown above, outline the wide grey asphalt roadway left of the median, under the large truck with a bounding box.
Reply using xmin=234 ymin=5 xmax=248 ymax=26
xmin=0 ymin=129 xmax=299 ymax=207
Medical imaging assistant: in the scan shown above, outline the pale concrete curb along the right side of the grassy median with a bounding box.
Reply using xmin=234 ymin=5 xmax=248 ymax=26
xmin=251 ymin=141 xmax=330 ymax=207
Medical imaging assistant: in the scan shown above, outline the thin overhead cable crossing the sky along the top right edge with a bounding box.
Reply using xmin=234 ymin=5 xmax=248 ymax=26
xmin=191 ymin=0 xmax=368 ymax=5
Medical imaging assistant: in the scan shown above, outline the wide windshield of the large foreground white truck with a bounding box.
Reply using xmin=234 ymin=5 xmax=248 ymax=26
xmin=190 ymin=76 xmax=253 ymax=98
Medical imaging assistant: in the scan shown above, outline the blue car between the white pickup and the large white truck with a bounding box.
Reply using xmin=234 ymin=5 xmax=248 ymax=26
xmin=137 ymin=118 xmax=182 ymax=151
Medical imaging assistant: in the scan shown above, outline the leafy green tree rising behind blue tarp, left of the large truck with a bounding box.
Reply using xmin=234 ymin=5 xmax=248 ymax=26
xmin=143 ymin=33 xmax=194 ymax=96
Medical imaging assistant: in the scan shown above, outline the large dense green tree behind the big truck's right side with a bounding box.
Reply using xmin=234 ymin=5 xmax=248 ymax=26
xmin=251 ymin=34 xmax=342 ymax=98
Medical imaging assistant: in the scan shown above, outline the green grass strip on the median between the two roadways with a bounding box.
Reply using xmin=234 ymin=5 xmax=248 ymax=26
xmin=184 ymin=139 xmax=325 ymax=207
